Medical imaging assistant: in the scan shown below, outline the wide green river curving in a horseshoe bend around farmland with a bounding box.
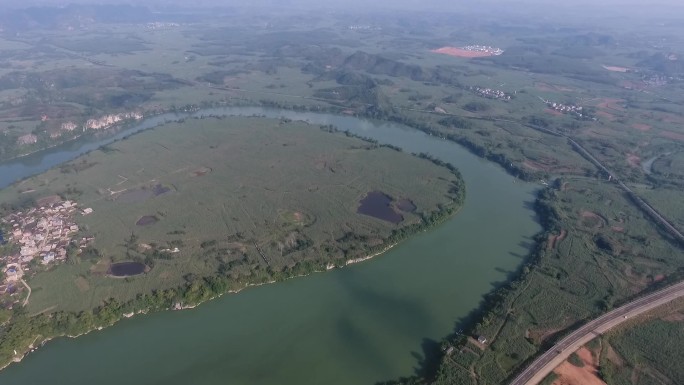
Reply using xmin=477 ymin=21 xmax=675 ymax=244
xmin=0 ymin=108 xmax=540 ymax=385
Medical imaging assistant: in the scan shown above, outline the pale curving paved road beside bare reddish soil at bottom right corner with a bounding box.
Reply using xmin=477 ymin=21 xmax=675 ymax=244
xmin=510 ymin=282 xmax=684 ymax=385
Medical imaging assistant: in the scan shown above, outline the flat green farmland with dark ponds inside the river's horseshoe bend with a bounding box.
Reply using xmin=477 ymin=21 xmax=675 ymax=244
xmin=0 ymin=118 xmax=458 ymax=312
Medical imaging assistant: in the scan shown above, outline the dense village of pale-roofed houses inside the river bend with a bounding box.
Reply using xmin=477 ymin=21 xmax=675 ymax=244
xmin=0 ymin=197 xmax=93 ymax=294
